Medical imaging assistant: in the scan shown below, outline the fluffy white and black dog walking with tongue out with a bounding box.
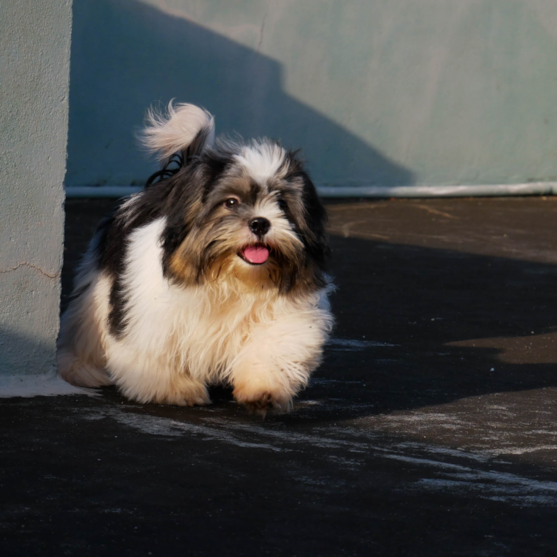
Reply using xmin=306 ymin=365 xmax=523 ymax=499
xmin=58 ymin=104 xmax=333 ymax=413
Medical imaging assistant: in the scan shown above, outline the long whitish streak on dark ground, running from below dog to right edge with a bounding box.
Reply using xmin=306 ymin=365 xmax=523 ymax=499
xmin=99 ymin=408 xmax=557 ymax=505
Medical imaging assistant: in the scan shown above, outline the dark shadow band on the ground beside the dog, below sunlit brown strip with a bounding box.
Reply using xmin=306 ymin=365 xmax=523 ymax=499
xmin=59 ymin=200 xmax=557 ymax=423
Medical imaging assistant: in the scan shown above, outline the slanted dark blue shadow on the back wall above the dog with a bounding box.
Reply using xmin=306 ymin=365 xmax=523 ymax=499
xmin=66 ymin=0 xmax=414 ymax=186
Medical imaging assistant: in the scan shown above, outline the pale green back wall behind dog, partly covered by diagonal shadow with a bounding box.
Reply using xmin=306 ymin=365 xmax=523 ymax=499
xmin=67 ymin=0 xmax=557 ymax=189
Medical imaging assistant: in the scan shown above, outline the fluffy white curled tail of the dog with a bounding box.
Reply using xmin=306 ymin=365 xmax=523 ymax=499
xmin=139 ymin=101 xmax=215 ymax=165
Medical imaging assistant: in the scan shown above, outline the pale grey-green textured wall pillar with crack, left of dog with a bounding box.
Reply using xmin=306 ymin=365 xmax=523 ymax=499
xmin=0 ymin=0 xmax=71 ymax=376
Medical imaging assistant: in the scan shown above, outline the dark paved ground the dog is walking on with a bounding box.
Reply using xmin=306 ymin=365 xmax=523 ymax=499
xmin=0 ymin=198 xmax=557 ymax=557
